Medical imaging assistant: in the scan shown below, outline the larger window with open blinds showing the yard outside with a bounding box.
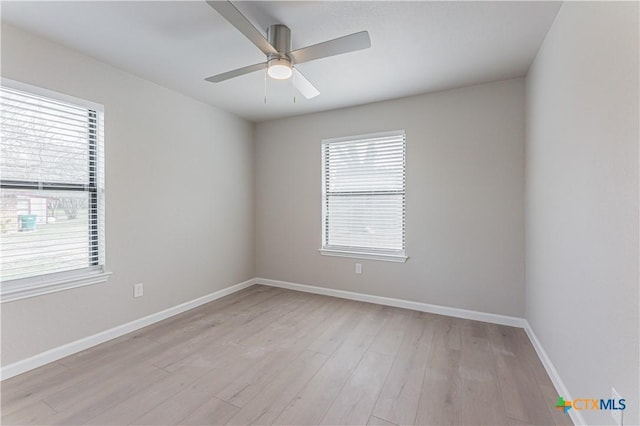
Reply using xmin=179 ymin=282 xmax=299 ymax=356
xmin=0 ymin=79 xmax=108 ymax=302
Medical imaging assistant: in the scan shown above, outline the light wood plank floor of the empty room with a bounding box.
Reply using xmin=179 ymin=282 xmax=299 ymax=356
xmin=1 ymin=285 xmax=571 ymax=425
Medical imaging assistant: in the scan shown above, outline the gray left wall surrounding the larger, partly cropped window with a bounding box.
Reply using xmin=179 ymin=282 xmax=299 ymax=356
xmin=1 ymin=24 xmax=254 ymax=365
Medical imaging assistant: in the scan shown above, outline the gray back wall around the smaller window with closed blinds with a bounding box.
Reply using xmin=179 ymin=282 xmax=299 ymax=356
xmin=255 ymin=79 xmax=525 ymax=316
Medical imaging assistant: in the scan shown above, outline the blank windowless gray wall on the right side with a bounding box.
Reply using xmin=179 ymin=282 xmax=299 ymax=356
xmin=526 ymin=2 xmax=640 ymax=424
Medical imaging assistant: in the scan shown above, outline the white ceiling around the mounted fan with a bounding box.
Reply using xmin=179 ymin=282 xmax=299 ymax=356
xmin=1 ymin=1 xmax=561 ymax=121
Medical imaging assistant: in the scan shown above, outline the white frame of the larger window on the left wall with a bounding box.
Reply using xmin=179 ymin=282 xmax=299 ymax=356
xmin=0 ymin=77 xmax=111 ymax=303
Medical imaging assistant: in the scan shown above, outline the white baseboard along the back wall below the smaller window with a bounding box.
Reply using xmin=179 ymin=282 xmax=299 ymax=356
xmin=255 ymin=278 xmax=527 ymax=328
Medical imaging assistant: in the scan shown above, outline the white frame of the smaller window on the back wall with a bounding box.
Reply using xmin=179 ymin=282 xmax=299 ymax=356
xmin=318 ymin=130 xmax=409 ymax=263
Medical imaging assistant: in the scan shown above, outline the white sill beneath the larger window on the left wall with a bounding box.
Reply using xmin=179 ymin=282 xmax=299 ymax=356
xmin=0 ymin=271 xmax=111 ymax=303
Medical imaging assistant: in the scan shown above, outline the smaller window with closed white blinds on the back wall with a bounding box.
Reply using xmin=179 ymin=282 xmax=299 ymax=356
xmin=320 ymin=131 xmax=407 ymax=262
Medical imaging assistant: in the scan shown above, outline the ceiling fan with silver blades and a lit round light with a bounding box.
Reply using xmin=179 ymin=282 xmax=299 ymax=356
xmin=205 ymin=0 xmax=371 ymax=99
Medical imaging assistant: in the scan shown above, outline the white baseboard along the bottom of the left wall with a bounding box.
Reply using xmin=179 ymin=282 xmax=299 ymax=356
xmin=0 ymin=278 xmax=255 ymax=380
